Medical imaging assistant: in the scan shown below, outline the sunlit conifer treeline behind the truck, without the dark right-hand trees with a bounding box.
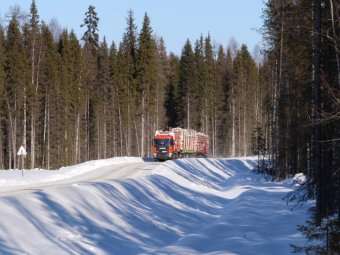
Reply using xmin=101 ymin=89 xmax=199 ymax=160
xmin=0 ymin=1 xmax=268 ymax=169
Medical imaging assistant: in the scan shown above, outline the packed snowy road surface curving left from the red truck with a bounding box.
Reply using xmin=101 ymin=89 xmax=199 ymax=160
xmin=0 ymin=162 xmax=159 ymax=197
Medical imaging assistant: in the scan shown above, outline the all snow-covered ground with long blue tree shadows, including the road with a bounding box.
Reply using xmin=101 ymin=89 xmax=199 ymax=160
xmin=0 ymin=158 xmax=308 ymax=255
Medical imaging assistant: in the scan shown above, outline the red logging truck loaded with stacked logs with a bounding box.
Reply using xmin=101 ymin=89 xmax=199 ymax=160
xmin=153 ymin=128 xmax=209 ymax=161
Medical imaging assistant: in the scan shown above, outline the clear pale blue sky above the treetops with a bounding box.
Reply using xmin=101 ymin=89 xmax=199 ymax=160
xmin=0 ymin=0 xmax=264 ymax=55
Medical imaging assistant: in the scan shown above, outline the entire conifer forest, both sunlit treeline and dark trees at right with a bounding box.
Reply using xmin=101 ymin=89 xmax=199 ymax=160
xmin=0 ymin=0 xmax=340 ymax=254
